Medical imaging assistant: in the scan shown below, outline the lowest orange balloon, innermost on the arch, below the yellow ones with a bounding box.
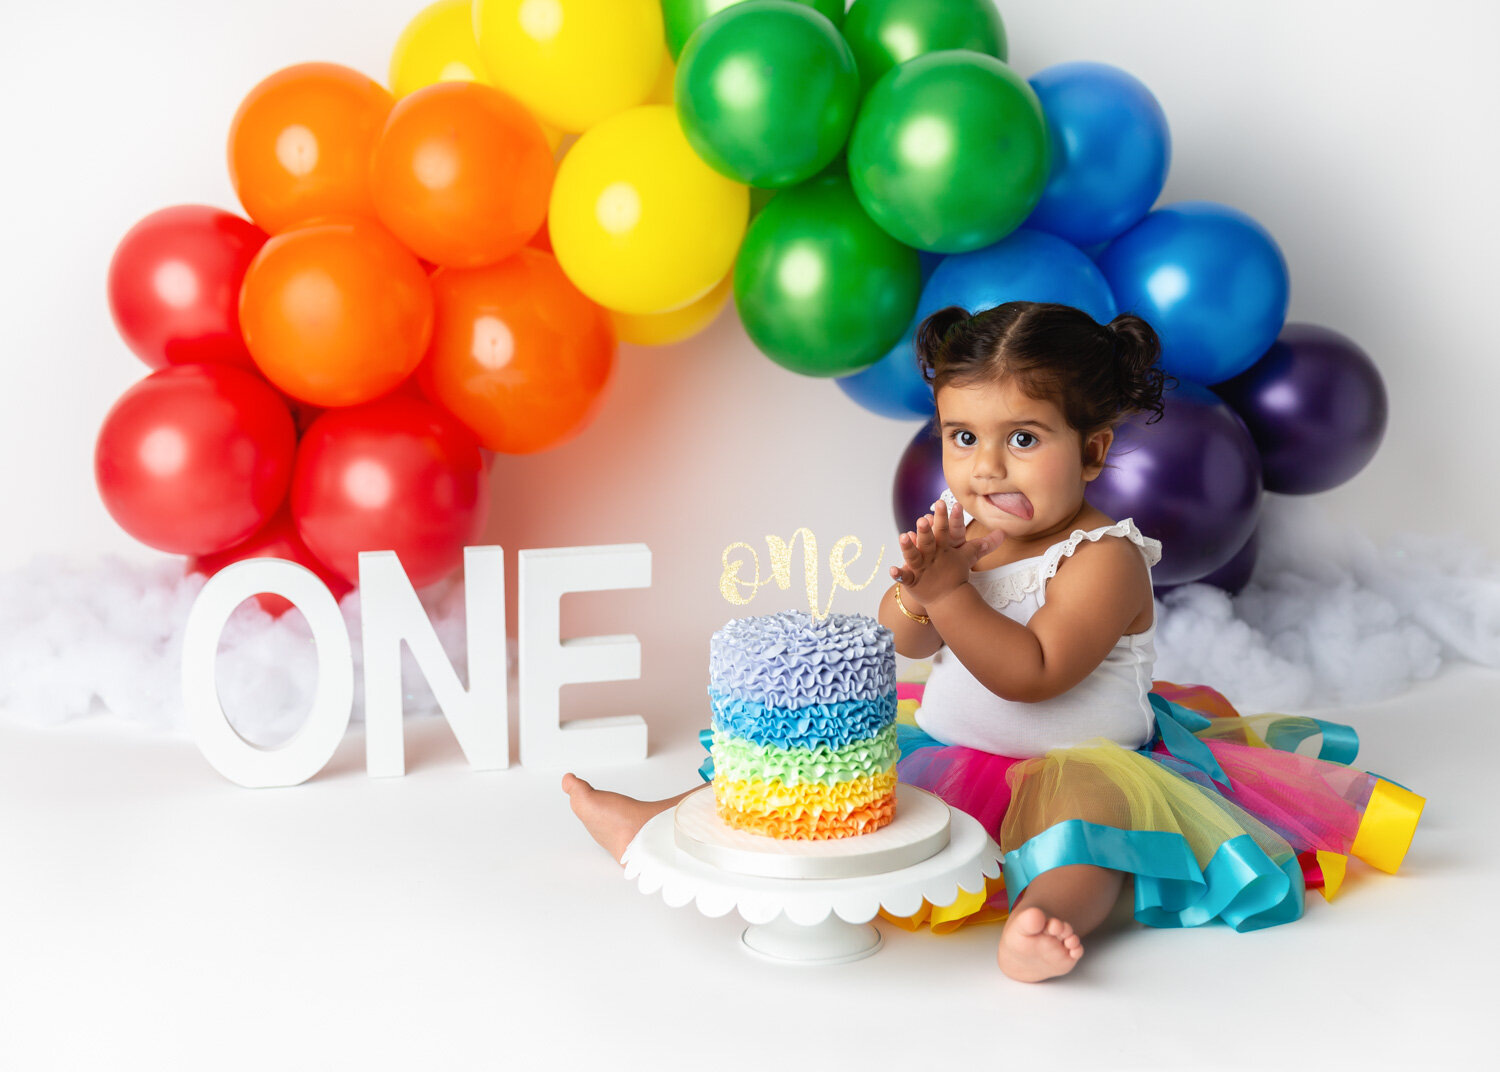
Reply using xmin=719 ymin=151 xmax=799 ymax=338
xmin=417 ymin=247 xmax=615 ymax=454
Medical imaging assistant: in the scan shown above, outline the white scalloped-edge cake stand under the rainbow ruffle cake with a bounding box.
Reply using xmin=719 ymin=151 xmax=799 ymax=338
xmin=621 ymin=786 xmax=1001 ymax=964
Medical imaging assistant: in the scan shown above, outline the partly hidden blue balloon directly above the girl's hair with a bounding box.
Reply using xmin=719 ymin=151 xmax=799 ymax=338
xmin=917 ymin=228 xmax=1115 ymax=324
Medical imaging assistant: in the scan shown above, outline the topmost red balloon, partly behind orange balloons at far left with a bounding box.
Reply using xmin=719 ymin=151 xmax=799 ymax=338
xmin=110 ymin=205 xmax=266 ymax=369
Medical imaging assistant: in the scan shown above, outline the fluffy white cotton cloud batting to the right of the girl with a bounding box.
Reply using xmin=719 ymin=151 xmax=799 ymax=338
xmin=1155 ymin=496 xmax=1500 ymax=712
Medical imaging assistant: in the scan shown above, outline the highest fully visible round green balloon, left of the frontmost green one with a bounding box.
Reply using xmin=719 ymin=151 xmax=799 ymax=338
xmin=677 ymin=0 xmax=860 ymax=187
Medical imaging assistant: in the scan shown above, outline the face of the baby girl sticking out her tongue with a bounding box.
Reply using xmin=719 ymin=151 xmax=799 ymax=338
xmin=938 ymin=379 xmax=1107 ymax=540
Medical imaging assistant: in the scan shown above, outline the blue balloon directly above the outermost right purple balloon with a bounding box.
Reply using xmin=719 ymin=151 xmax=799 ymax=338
xmin=1098 ymin=201 xmax=1289 ymax=384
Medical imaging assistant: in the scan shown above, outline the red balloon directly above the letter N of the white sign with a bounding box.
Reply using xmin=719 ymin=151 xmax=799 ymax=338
xmin=291 ymin=394 xmax=489 ymax=588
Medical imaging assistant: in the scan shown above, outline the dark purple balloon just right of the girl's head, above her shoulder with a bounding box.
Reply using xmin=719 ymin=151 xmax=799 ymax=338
xmin=1088 ymin=382 xmax=1260 ymax=585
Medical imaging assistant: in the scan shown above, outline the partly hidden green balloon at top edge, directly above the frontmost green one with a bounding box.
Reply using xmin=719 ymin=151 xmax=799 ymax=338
xmin=843 ymin=0 xmax=1007 ymax=91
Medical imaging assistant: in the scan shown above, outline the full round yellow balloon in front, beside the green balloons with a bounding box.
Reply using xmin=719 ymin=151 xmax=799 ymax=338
xmin=548 ymin=105 xmax=750 ymax=313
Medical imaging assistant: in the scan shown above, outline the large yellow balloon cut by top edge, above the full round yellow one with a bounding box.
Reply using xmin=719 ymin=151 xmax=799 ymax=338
xmin=474 ymin=0 xmax=666 ymax=133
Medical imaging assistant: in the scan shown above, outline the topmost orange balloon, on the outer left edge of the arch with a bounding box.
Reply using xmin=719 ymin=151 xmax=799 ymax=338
xmin=230 ymin=63 xmax=396 ymax=234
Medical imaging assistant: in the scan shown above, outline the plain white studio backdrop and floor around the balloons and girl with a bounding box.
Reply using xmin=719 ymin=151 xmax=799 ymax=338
xmin=0 ymin=0 xmax=1500 ymax=1071
